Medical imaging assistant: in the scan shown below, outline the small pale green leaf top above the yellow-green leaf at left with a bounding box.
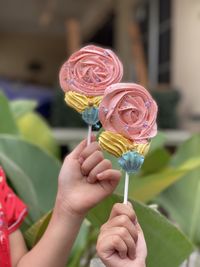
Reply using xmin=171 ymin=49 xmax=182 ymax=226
xmin=10 ymin=99 xmax=37 ymax=119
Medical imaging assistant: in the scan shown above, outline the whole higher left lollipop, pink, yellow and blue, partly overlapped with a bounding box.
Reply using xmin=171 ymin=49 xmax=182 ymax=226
xmin=59 ymin=45 xmax=123 ymax=144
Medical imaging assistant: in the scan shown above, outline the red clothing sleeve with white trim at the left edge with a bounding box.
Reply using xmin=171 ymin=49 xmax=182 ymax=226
xmin=0 ymin=167 xmax=27 ymax=267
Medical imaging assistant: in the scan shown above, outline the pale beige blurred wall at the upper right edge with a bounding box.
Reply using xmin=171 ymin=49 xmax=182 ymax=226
xmin=172 ymin=0 xmax=200 ymax=118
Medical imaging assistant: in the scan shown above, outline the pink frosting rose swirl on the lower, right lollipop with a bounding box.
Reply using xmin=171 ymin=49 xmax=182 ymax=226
xmin=99 ymin=83 xmax=158 ymax=143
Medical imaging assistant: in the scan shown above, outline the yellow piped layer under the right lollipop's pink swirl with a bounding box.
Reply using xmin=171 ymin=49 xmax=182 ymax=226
xmin=99 ymin=131 xmax=150 ymax=157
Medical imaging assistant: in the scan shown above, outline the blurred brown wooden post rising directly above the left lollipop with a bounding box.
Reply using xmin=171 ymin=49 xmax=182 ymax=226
xmin=65 ymin=18 xmax=82 ymax=55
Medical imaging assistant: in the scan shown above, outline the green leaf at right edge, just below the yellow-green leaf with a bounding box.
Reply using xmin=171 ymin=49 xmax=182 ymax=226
xmin=156 ymin=173 xmax=200 ymax=247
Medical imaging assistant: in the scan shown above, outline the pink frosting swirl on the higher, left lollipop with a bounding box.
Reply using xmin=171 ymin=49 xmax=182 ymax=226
xmin=59 ymin=45 xmax=123 ymax=96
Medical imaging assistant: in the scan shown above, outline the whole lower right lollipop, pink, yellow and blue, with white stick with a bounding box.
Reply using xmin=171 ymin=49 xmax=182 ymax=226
xmin=99 ymin=83 xmax=158 ymax=203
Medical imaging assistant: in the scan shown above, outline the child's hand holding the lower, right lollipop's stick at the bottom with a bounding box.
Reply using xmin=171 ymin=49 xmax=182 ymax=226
xmin=97 ymin=204 xmax=147 ymax=267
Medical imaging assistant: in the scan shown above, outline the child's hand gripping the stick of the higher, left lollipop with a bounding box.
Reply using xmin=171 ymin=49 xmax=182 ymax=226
xmin=57 ymin=137 xmax=121 ymax=219
